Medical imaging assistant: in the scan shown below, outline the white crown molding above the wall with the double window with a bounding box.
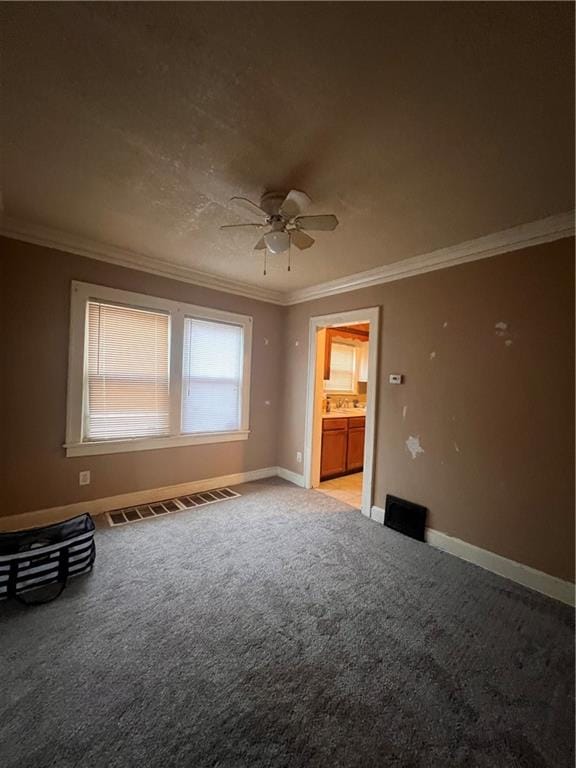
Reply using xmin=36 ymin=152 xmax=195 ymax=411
xmin=0 ymin=217 xmax=284 ymax=304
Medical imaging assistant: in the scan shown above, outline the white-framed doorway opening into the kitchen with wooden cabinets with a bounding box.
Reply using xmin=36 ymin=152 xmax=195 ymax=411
xmin=304 ymin=307 xmax=380 ymax=517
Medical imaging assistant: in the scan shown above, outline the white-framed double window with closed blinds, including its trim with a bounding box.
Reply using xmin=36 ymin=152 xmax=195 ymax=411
xmin=65 ymin=282 xmax=252 ymax=456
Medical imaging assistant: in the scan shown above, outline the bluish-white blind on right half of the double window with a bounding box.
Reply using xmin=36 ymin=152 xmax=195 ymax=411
xmin=182 ymin=317 xmax=244 ymax=434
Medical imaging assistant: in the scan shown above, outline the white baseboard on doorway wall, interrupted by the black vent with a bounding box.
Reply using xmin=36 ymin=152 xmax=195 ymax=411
xmin=371 ymin=507 xmax=576 ymax=606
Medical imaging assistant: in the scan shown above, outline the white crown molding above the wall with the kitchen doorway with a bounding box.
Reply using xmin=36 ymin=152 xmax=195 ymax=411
xmin=284 ymin=211 xmax=574 ymax=305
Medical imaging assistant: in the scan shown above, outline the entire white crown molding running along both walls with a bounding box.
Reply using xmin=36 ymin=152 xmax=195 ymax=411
xmin=0 ymin=211 xmax=574 ymax=306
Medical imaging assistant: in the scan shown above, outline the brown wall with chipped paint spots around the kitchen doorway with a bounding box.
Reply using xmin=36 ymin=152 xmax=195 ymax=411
xmin=279 ymin=239 xmax=574 ymax=579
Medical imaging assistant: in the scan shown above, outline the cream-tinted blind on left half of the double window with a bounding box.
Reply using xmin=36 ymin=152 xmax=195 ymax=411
xmin=84 ymin=301 xmax=170 ymax=440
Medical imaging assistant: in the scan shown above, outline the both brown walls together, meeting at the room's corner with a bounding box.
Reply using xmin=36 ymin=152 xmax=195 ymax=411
xmin=0 ymin=234 xmax=574 ymax=579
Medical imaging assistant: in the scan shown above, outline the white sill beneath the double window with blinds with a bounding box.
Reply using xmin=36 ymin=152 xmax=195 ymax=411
xmin=64 ymin=429 xmax=250 ymax=457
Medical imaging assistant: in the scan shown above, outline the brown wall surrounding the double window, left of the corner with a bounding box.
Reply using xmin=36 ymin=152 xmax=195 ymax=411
xmin=0 ymin=238 xmax=283 ymax=515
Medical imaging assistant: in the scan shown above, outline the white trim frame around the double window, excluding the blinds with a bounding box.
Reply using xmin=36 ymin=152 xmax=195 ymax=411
xmin=64 ymin=280 xmax=252 ymax=457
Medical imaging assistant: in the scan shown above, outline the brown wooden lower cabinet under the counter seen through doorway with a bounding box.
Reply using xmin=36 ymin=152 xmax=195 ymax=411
xmin=320 ymin=416 xmax=365 ymax=480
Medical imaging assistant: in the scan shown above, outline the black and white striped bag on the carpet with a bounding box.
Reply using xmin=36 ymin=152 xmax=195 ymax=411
xmin=0 ymin=515 xmax=96 ymax=605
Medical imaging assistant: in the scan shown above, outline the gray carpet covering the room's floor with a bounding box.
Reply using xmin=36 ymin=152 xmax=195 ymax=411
xmin=0 ymin=480 xmax=574 ymax=768
